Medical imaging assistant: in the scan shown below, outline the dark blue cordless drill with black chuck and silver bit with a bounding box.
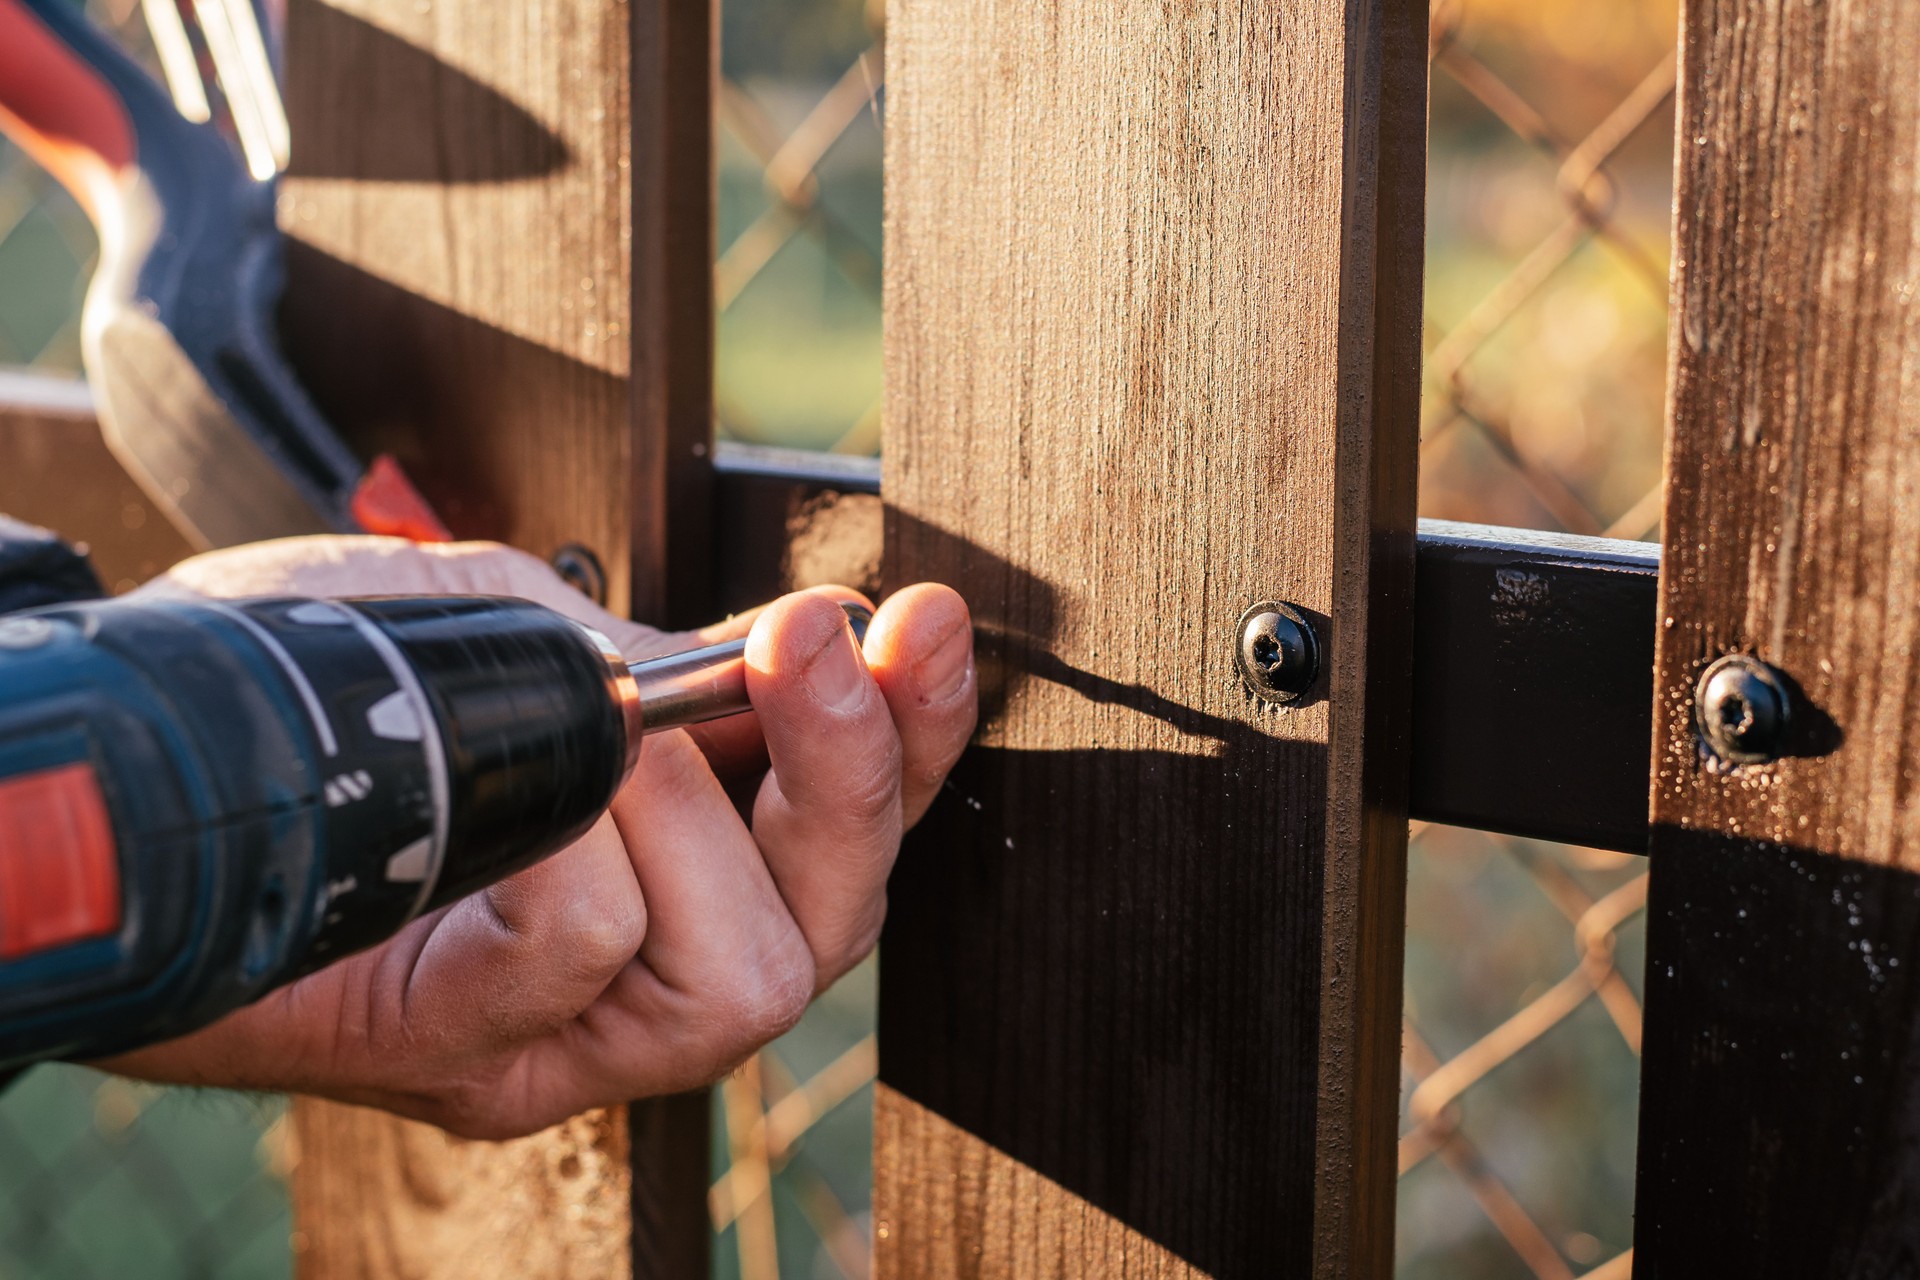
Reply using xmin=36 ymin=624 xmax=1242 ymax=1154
xmin=0 ymin=597 xmax=866 ymax=1073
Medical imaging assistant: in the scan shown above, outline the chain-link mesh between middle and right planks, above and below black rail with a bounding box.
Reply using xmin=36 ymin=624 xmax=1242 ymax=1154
xmin=1398 ymin=0 xmax=1678 ymax=1280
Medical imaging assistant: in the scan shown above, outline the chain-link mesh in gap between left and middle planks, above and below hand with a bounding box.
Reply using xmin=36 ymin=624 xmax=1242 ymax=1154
xmin=708 ymin=0 xmax=885 ymax=1280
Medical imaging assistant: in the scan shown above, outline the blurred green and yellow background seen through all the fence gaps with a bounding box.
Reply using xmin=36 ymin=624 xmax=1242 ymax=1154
xmin=0 ymin=0 xmax=1676 ymax=1280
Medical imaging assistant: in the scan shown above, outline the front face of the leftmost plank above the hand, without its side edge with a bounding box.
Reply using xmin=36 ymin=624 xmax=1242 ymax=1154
xmin=282 ymin=0 xmax=649 ymax=610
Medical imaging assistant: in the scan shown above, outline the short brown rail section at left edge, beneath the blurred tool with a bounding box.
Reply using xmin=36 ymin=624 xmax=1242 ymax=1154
xmin=0 ymin=374 xmax=192 ymax=591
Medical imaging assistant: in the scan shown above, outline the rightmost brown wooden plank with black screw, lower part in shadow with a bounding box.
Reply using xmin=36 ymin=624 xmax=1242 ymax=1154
xmin=1634 ymin=0 xmax=1920 ymax=1278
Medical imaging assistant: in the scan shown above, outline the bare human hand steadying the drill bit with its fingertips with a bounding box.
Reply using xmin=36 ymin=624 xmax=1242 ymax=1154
xmin=100 ymin=537 xmax=975 ymax=1138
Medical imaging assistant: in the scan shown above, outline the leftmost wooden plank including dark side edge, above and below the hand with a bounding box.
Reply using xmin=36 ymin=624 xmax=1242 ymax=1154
xmin=282 ymin=0 xmax=714 ymax=1278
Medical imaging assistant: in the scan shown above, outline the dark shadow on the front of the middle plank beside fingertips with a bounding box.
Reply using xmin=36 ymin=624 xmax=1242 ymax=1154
xmin=879 ymin=510 xmax=1327 ymax=1276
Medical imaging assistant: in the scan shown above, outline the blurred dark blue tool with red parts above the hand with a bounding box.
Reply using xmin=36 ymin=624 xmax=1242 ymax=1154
xmin=0 ymin=0 xmax=447 ymax=547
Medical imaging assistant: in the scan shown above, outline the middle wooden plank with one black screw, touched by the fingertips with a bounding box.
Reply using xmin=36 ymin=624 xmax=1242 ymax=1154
xmin=876 ymin=0 xmax=1425 ymax=1276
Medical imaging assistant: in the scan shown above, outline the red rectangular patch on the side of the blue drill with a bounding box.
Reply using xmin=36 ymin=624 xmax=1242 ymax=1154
xmin=0 ymin=764 xmax=121 ymax=960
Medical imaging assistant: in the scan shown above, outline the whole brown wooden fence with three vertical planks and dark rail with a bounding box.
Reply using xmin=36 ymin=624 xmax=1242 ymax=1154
xmin=0 ymin=0 xmax=1920 ymax=1278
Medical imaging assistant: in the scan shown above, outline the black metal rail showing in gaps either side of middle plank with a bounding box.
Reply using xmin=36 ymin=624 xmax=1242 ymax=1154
xmin=714 ymin=445 xmax=1661 ymax=854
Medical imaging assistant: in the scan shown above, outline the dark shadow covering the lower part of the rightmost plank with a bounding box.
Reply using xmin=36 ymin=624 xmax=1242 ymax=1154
xmin=1634 ymin=825 xmax=1920 ymax=1280
